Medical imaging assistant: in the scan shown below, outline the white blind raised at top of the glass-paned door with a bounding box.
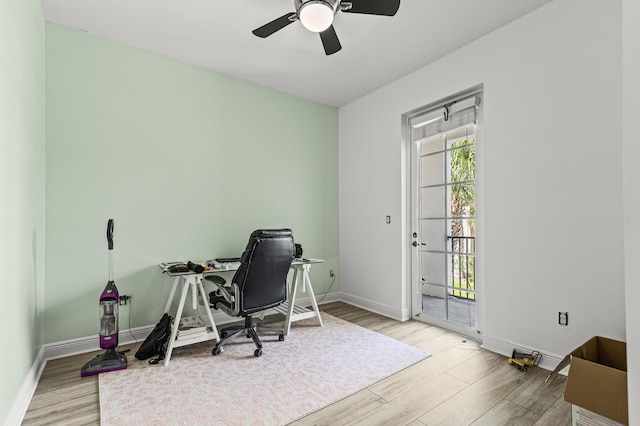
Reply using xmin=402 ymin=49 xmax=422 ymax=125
xmin=409 ymin=96 xmax=480 ymax=142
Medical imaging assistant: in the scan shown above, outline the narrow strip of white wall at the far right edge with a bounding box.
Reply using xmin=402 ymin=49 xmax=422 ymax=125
xmin=622 ymin=0 xmax=640 ymax=425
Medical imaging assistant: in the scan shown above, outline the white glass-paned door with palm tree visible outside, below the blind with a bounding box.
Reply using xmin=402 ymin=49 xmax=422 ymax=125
xmin=411 ymin=123 xmax=477 ymax=335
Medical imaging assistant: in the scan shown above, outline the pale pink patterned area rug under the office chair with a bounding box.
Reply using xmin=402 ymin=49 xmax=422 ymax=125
xmin=99 ymin=313 xmax=429 ymax=426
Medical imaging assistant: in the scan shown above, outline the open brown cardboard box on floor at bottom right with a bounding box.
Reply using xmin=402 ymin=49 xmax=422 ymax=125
xmin=558 ymin=336 xmax=629 ymax=425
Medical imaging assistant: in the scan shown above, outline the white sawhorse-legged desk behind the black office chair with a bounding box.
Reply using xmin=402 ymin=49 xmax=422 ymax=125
xmin=159 ymin=259 xmax=324 ymax=366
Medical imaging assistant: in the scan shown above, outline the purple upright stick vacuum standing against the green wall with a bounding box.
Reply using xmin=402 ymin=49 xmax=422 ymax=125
xmin=80 ymin=219 xmax=127 ymax=377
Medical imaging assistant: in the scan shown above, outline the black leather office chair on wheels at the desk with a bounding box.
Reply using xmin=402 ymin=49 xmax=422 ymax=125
xmin=205 ymin=229 xmax=294 ymax=357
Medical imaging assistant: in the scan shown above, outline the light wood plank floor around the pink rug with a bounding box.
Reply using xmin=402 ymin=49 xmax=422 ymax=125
xmin=22 ymin=302 xmax=571 ymax=426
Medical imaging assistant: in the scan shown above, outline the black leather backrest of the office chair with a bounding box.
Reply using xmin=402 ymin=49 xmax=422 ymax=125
xmin=232 ymin=229 xmax=295 ymax=316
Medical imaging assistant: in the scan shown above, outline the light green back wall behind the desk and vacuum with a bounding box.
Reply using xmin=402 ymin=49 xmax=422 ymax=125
xmin=45 ymin=23 xmax=338 ymax=342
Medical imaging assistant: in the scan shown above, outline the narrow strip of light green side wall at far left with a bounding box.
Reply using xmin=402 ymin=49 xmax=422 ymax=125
xmin=0 ymin=0 xmax=45 ymax=424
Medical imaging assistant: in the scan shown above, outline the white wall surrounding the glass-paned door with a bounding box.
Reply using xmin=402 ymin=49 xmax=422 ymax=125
xmin=339 ymin=0 xmax=625 ymax=357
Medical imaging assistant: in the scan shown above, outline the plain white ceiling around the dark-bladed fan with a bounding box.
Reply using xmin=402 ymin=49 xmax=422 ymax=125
xmin=40 ymin=0 xmax=551 ymax=107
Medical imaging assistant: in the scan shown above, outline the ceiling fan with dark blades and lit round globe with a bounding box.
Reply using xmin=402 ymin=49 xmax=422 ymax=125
xmin=252 ymin=0 xmax=400 ymax=55
